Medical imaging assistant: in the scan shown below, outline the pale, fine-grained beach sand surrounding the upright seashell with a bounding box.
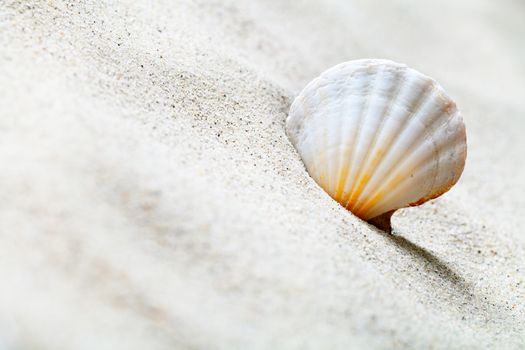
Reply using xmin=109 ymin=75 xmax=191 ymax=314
xmin=0 ymin=0 xmax=525 ymax=349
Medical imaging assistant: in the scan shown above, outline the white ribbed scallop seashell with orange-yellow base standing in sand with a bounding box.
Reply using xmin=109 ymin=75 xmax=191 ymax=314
xmin=286 ymin=59 xmax=467 ymax=231
